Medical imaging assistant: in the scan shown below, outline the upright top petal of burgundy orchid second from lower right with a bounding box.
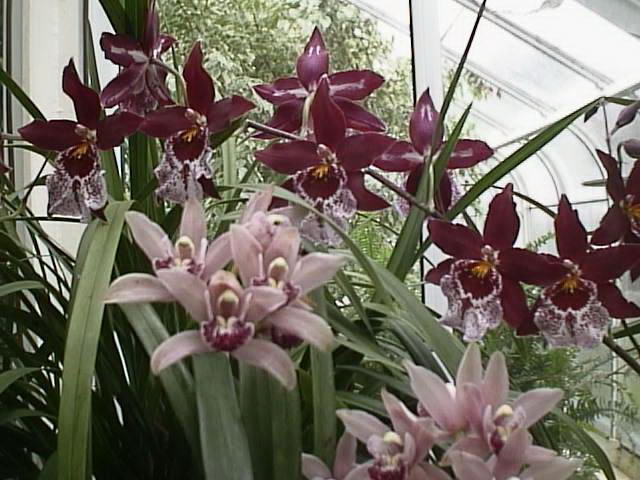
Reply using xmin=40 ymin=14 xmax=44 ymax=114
xmin=484 ymin=183 xmax=520 ymax=250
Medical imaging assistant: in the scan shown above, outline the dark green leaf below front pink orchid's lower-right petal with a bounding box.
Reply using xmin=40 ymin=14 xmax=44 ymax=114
xmin=240 ymin=363 xmax=302 ymax=480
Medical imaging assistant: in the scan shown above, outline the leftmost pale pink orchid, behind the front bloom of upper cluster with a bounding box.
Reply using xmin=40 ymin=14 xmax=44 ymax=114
xmin=105 ymin=199 xmax=229 ymax=303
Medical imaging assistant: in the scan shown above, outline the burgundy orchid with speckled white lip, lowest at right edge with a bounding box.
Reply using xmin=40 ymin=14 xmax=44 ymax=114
xmin=520 ymin=195 xmax=640 ymax=348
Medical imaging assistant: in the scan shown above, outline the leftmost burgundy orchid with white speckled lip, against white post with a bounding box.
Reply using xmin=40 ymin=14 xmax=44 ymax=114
xmin=18 ymin=60 xmax=142 ymax=220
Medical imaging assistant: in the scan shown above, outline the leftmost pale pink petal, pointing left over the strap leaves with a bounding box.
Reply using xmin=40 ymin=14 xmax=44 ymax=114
xmin=104 ymin=273 xmax=174 ymax=304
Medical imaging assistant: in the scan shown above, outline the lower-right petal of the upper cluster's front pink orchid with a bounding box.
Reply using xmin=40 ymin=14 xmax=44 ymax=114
xmin=231 ymin=338 xmax=296 ymax=390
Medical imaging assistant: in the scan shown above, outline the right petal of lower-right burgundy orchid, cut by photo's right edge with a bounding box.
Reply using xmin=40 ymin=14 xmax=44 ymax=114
xmin=580 ymin=244 xmax=640 ymax=283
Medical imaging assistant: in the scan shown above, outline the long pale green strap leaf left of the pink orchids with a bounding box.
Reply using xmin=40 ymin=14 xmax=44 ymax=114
xmin=58 ymin=202 xmax=131 ymax=480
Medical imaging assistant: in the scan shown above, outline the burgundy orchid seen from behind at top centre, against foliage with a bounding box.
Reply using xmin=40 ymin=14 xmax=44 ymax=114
xmin=253 ymin=27 xmax=385 ymax=138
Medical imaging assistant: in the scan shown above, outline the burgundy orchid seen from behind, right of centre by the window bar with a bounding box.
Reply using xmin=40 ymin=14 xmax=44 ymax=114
xmin=374 ymin=89 xmax=493 ymax=212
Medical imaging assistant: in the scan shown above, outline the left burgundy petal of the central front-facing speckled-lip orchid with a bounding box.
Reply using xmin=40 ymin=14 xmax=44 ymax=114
xmin=255 ymin=140 xmax=322 ymax=175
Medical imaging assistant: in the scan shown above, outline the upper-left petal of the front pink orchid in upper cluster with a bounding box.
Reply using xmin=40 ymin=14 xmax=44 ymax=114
xmin=156 ymin=268 xmax=210 ymax=322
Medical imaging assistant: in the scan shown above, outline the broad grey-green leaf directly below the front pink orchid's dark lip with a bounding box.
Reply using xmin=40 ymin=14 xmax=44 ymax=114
xmin=193 ymin=353 xmax=254 ymax=480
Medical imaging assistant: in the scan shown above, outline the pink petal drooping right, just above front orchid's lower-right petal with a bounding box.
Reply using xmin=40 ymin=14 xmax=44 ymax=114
xmin=268 ymin=307 xmax=333 ymax=351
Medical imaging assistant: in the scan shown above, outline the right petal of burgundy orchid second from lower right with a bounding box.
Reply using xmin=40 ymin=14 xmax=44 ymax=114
xmin=498 ymin=248 xmax=568 ymax=287
